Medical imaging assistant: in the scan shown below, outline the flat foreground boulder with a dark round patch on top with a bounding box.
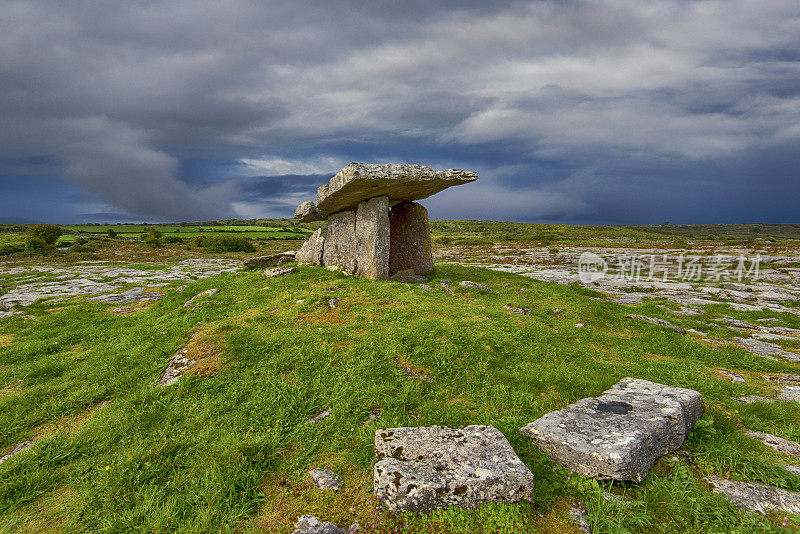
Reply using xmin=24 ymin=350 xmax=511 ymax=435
xmin=520 ymin=378 xmax=703 ymax=482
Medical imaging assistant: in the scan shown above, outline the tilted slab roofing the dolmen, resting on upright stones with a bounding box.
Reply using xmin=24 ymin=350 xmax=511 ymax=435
xmin=316 ymin=163 xmax=478 ymax=220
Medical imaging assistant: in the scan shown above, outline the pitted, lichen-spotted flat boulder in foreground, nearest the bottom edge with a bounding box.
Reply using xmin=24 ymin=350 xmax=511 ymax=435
xmin=373 ymin=425 xmax=534 ymax=511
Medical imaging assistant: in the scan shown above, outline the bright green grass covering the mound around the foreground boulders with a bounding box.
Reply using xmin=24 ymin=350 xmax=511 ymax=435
xmin=0 ymin=265 xmax=800 ymax=533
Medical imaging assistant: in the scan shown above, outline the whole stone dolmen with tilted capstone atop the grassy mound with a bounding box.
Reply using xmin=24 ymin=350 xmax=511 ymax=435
xmin=295 ymin=163 xmax=478 ymax=280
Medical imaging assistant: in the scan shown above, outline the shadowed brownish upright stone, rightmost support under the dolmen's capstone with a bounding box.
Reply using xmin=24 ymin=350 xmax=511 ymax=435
xmin=389 ymin=202 xmax=433 ymax=274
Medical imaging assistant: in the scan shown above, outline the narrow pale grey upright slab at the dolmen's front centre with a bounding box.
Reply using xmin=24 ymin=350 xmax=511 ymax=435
xmin=356 ymin=197 xmax=389 ymax=280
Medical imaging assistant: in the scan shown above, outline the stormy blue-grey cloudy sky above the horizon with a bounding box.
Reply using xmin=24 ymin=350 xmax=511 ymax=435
xmin=0 ymin=0 xmax=800 ymax=224
